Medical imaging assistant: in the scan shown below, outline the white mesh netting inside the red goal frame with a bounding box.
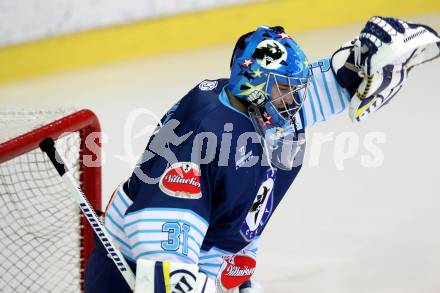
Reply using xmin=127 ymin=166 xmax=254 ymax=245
xmin=0 ymin=112 xmax=81 ymax=293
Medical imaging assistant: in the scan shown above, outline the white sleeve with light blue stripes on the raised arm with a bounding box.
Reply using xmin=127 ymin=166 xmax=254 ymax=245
xmin=301 ymin=58 xmax=350 ymax=128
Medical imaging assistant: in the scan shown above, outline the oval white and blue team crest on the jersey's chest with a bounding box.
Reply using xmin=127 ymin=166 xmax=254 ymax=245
xmin=240 ymin=169 xmax=275 ymax=241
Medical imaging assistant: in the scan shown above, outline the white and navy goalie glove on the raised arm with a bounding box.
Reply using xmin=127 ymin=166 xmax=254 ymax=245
xmin=331 ymin=17 xmax=440 ymax=121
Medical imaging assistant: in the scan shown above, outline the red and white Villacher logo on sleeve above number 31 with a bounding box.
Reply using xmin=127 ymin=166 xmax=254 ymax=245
xmin=159 ymin=162 xmax=202 ymax=199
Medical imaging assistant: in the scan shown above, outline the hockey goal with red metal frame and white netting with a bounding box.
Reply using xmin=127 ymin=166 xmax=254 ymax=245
xmin=0 ymin=110 xmax=101 ymax=293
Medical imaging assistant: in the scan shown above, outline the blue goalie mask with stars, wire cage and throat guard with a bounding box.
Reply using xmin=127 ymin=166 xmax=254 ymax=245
xmin=227 ymin=26 xmax=310 ymax=170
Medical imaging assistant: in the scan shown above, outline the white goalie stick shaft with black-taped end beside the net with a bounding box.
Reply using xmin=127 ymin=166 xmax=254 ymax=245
xmin=40 ymin=138 xmax=136 ymax=291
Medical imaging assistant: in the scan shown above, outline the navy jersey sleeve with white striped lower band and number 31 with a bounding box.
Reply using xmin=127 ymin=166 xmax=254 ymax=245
xmin=105 ymin=100 xmax=215 ymax=264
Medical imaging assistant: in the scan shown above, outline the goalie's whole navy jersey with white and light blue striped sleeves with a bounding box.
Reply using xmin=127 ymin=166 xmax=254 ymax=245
xmin=100 ymin=59 xmax=349 ymax=288
